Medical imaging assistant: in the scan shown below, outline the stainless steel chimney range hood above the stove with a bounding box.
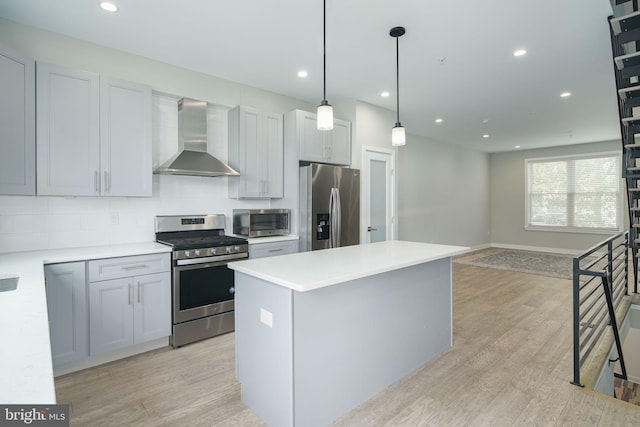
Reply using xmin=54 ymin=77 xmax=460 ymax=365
xmin=153 ymin=98 xmax=240 ymax=176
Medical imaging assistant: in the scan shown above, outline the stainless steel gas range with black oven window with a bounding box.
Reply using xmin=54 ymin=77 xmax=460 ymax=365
xmin=155 ymin=214 xmax=249 ymax=348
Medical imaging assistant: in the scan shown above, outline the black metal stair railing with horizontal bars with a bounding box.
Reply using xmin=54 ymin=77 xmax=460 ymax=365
xmin=571 ymin=231 xmax=629 ymax=387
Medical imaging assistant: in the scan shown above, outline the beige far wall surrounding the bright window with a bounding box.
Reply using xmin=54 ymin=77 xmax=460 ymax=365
xmin=491 ymin=141 xmax=628 ymax=253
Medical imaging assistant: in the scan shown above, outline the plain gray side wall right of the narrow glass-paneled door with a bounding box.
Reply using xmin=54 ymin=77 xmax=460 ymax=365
xmin=398 ymin=132 xmax=490 ymax=247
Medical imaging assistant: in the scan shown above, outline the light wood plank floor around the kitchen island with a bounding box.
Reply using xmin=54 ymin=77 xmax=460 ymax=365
xmin=56 ymin=263 xmax=640 ymax=427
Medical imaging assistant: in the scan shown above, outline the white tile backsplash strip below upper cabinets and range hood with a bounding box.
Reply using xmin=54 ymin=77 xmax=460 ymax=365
xmin=0 ymin=175 xmax=270 ymax=253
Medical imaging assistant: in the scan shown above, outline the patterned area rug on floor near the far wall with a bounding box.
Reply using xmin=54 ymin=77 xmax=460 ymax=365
xmin=454 ymin=249 xmax=573 ymax=279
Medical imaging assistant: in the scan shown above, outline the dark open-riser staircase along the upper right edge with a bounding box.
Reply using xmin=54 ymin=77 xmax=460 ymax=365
xmin=609 ymin=0 xmax=640 ymax=293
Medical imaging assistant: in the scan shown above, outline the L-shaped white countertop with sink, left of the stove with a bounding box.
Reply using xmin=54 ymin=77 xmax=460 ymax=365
xmin=0 ymin=242 xmax=171 ymax=404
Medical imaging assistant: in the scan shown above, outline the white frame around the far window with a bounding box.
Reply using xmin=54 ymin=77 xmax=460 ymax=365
xmin=524 ymin=151 xmax=625 ymax=234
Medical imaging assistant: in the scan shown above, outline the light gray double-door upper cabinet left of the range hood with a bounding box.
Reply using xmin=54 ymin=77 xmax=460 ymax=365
xmin=36 ymin=62 xmax=152 ymax=196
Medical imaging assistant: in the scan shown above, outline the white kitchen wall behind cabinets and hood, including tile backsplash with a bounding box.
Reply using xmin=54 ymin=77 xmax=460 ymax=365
xmin=0 ymin=19 xmax=324 ymax=252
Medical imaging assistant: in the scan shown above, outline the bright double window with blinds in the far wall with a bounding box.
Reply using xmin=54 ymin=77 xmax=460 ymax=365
xmin=525 ymin=153 xmax=622 ymax=232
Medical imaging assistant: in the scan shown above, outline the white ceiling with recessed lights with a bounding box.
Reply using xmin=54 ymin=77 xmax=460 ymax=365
xmin=0 ymin=0 xmax=620 ymax=152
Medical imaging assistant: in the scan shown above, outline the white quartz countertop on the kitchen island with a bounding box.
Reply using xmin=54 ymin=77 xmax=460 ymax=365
xmin=229 ymin=240 xmax=469 ymax=292
